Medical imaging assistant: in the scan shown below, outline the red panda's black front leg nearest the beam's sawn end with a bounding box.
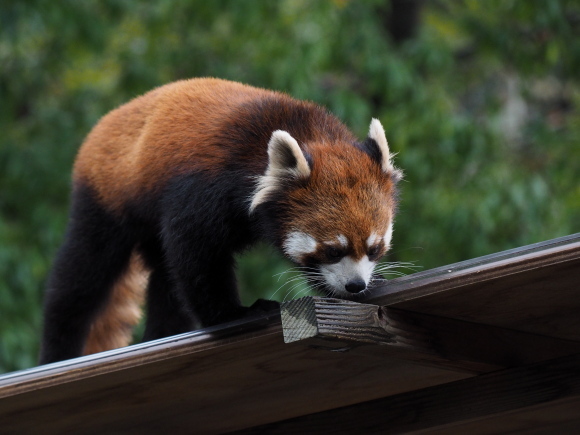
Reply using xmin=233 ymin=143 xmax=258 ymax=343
xmin=156 ymin=174 xmax=274 ymax=327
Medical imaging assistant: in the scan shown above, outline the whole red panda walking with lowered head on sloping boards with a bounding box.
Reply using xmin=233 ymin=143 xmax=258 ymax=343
xmin=40 ymin=78 xmax=401 ymax=364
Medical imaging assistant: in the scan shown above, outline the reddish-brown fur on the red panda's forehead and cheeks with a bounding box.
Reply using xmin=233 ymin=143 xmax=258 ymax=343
xmin=285 ymin=143 xmax=395 ymax=259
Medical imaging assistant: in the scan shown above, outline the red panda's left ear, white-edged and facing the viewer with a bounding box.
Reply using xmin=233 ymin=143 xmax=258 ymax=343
xmin=250 ymin=130 xmax=310 ymax=213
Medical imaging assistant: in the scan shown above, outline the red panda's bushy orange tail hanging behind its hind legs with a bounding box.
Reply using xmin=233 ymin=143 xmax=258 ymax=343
xmin=83 ymin=252 xmax=149 ymax=355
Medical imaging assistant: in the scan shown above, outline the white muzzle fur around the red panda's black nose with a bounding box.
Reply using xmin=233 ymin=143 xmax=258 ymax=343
xmin=320 ymin=255 xmax=375 ymax=296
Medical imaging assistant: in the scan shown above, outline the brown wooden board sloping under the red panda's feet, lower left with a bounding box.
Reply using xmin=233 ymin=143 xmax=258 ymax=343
xmin=0 ymin=314 xmax=470 ymax=434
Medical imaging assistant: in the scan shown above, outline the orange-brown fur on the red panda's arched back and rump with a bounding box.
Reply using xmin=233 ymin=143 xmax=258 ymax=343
xmin=73 ymin=79 xmax=276 ymax=214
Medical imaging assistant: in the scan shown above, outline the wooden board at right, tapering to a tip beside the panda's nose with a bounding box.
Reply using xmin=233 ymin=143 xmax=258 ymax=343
xmin=363 ymin=234 xmax=580 ymax=341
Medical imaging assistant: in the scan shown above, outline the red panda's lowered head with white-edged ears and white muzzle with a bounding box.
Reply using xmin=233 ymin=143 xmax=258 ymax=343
xmin=250 ymin=119 xmax=402 ymax=299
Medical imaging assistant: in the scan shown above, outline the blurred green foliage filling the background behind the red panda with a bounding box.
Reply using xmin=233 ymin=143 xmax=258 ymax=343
xmin=0 ymin=0 xmax=580 ymax=372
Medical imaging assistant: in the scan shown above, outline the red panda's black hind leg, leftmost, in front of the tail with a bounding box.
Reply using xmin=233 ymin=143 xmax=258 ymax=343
xmin=40 ymin=186 xmax=134 ymax=364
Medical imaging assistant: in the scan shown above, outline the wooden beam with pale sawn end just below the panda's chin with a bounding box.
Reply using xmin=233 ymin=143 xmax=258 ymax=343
xmin=281 ymin=296 xmax=580 ymax=373
